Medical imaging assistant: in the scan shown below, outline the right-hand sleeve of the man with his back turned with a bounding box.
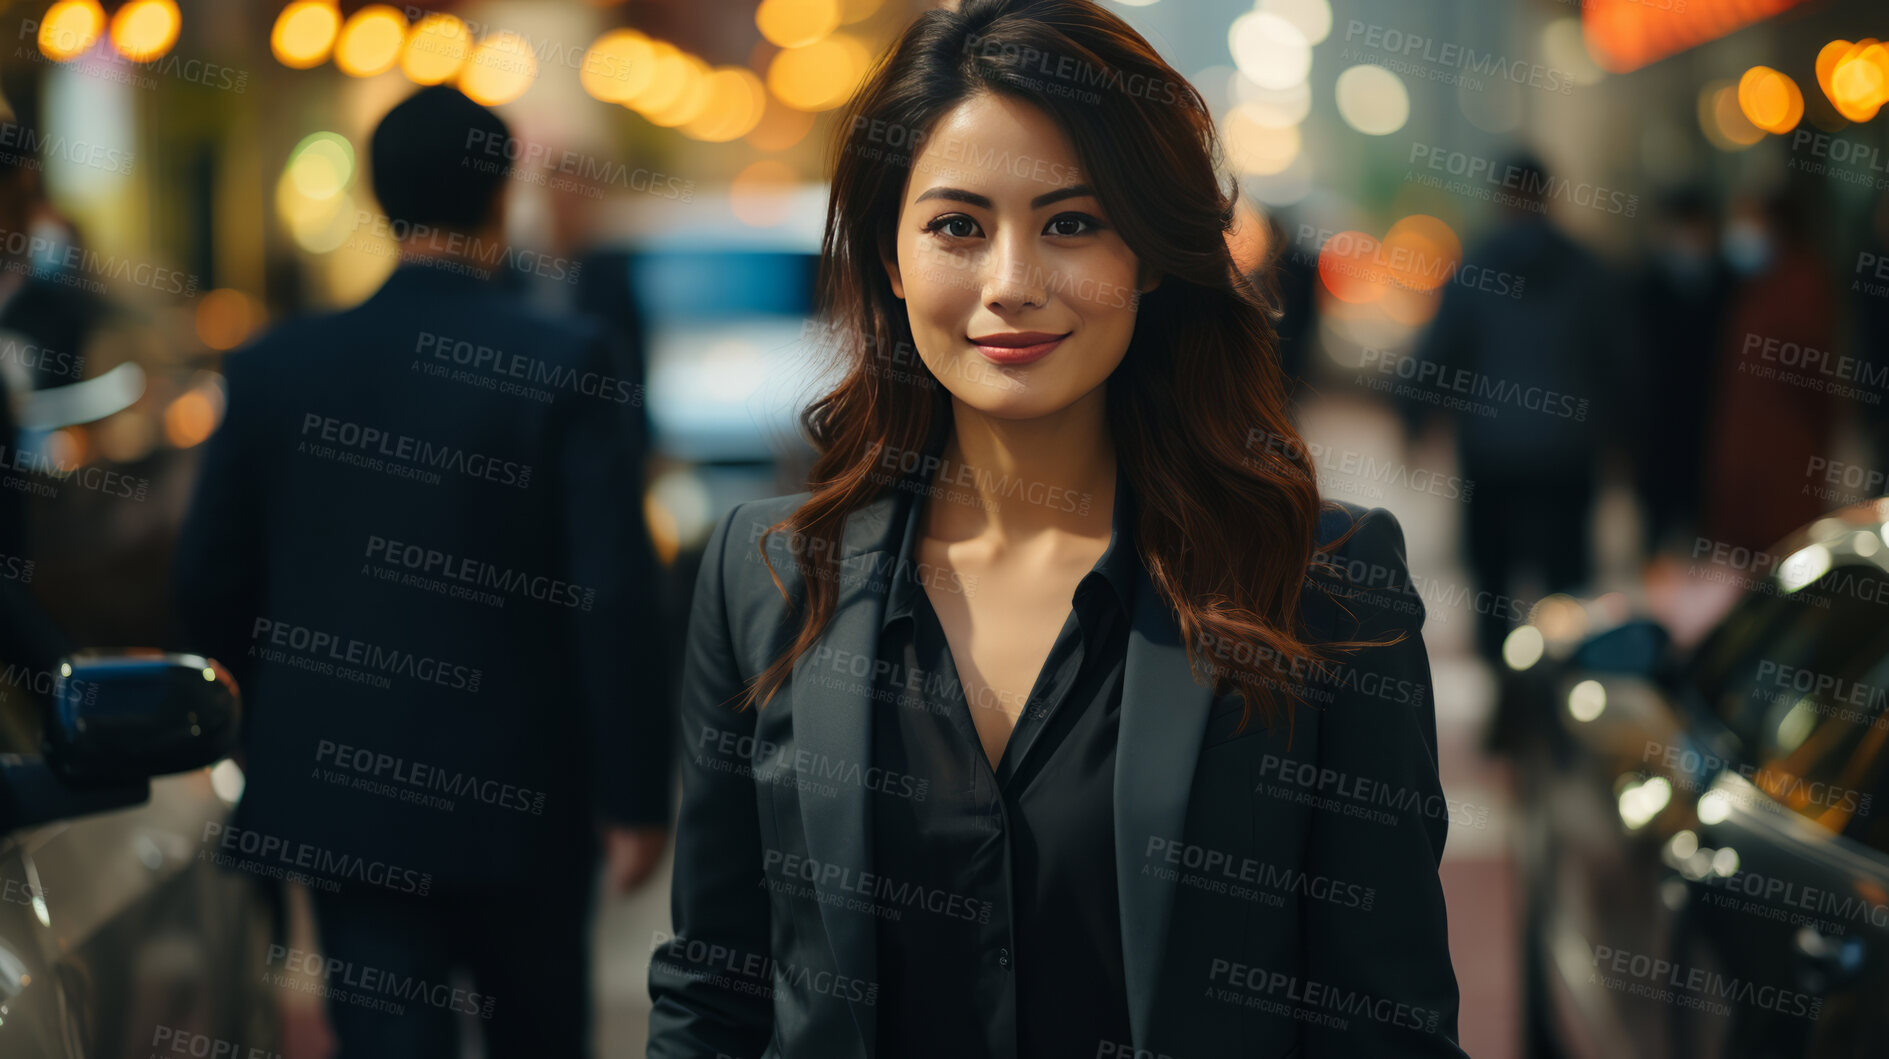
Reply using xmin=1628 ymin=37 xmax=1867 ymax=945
xmin=557 ymin=328 xmax=676 ymax=827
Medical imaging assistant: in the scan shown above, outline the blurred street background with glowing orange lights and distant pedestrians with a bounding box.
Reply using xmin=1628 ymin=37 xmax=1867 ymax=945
xmin=11 ymin=0 xmax=1889 ymax=1059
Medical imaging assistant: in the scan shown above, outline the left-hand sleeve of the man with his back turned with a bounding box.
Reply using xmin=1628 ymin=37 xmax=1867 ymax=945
xmin=170 ymin=349 xmax=266 ymax=694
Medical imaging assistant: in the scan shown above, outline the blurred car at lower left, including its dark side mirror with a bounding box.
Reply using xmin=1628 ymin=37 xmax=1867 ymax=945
xmin=0 ymin=651 xmax=278 ymax=1059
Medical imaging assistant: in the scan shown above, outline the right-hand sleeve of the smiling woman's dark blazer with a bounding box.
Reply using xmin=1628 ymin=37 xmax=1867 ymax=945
xmin=1302 ymin=508 xmax=1464 ymax=1059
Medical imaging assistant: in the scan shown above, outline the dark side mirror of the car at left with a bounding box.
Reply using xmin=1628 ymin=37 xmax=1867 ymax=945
xmin=45 ymin=647 xmax=242 ymax=783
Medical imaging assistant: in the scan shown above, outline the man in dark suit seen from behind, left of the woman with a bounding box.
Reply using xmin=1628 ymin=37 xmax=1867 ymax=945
xmin=176 ymin=87 xmax=672 ymax=1057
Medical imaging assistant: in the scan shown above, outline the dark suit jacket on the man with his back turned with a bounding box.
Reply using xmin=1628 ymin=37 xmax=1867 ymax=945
xmin=174 ymin=264 xmax=674 ymax=891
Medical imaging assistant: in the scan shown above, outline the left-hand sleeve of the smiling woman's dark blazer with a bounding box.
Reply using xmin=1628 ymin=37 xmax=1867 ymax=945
xmin=648 ymin=506 xmax=774 ymax=1059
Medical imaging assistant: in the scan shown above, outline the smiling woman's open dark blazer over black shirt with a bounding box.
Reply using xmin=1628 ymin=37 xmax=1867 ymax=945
xmin=648 ymin=493 xmax=1462 ymax=1059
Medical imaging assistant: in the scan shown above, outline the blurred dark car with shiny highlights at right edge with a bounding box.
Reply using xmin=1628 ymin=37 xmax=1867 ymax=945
xmin=1502 ymin=498 xmax=1889 ymax=1059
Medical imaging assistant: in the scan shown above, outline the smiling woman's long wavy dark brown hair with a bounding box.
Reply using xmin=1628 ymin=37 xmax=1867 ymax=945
xmin=740 ymin=0 xmax=1360 ymax=727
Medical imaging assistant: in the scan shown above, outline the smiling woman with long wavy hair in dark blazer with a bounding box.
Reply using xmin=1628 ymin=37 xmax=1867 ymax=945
xmin=650 ymin=0 xmax=1462 ymax=1059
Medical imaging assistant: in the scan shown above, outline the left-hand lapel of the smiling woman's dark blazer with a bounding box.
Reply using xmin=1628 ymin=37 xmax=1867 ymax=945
xmin=791 ymin=495 xmax=897 ymax=1057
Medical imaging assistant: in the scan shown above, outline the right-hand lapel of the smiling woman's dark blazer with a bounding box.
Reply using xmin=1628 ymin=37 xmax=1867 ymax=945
xmin=1115 ymin=570 xmax=1213 ymax=1051
